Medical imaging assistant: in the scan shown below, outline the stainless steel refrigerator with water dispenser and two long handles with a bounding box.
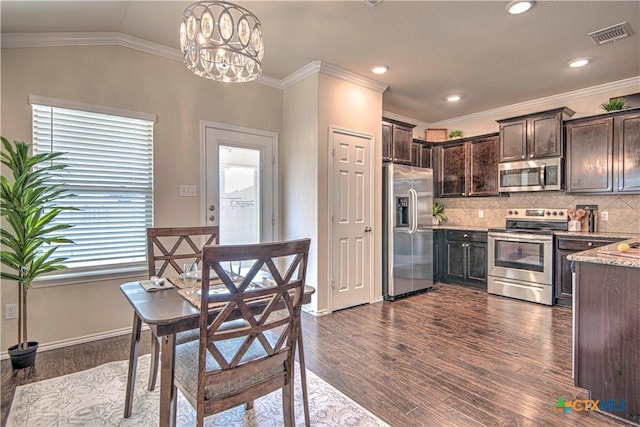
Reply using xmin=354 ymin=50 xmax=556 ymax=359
xmin=382 ymin=163 xmax=433 ymax=301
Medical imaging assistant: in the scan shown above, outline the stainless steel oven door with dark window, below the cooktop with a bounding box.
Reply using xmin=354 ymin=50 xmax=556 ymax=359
xmin=488 ymin=231 xmax=553 ymax=285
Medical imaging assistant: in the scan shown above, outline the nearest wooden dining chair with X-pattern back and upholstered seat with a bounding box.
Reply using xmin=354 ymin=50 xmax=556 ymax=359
xmin=171 ymin=239 xmax=310 ymax=426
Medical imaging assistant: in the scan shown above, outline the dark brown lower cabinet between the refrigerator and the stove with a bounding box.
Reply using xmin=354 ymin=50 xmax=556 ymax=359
xmin=442 ymin=230 xmax=487 ymax=290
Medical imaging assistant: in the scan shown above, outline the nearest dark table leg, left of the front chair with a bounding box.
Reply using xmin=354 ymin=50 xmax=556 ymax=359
xmin=160 ymin=334 xmax=178 ymax=427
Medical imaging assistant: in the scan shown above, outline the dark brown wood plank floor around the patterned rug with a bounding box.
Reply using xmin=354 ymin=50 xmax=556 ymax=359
xmin=1 ymin=284 xmax=626 ymax=427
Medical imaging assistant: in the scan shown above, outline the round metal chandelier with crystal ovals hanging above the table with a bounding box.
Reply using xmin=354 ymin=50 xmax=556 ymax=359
xmin=180 ymin=1 xmax=264 ymax=83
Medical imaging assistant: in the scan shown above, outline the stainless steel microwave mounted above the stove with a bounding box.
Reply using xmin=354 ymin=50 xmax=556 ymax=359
xmin=498 ymin=157 xmax=564 ymax=193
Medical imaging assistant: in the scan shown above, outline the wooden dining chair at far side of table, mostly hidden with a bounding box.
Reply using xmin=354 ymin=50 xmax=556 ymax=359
xmin=147 ymin=226 xmax=220 ymax=391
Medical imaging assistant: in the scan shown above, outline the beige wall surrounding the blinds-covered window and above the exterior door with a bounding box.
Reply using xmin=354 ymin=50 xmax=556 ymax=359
xmin=0 ymin=46 xmax=282 ymax=352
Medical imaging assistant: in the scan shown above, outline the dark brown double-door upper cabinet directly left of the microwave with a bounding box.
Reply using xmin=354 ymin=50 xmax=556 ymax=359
xmin=434 ymin=134 xmax=498 ymax=197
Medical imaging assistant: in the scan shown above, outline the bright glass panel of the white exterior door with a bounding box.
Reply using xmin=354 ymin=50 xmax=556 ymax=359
xmin=218 ymin=145 xmax=262 ymax=244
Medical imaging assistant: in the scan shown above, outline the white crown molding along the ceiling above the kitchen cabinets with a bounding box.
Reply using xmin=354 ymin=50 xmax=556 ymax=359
xmin=428 ymin=76 xmax=640 ymax=127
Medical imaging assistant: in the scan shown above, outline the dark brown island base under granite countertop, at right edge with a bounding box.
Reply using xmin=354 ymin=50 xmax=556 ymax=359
xmin=574 ymin=262 xmax=640 ymax=423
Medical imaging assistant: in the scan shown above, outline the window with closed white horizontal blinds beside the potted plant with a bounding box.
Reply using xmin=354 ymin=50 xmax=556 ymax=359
xmin=30 ymin=97 xmax=155 ymax=276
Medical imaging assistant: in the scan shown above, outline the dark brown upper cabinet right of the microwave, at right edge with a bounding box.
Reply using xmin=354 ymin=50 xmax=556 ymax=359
xmin=565 ymin=110 xmax=640 ymax=194
